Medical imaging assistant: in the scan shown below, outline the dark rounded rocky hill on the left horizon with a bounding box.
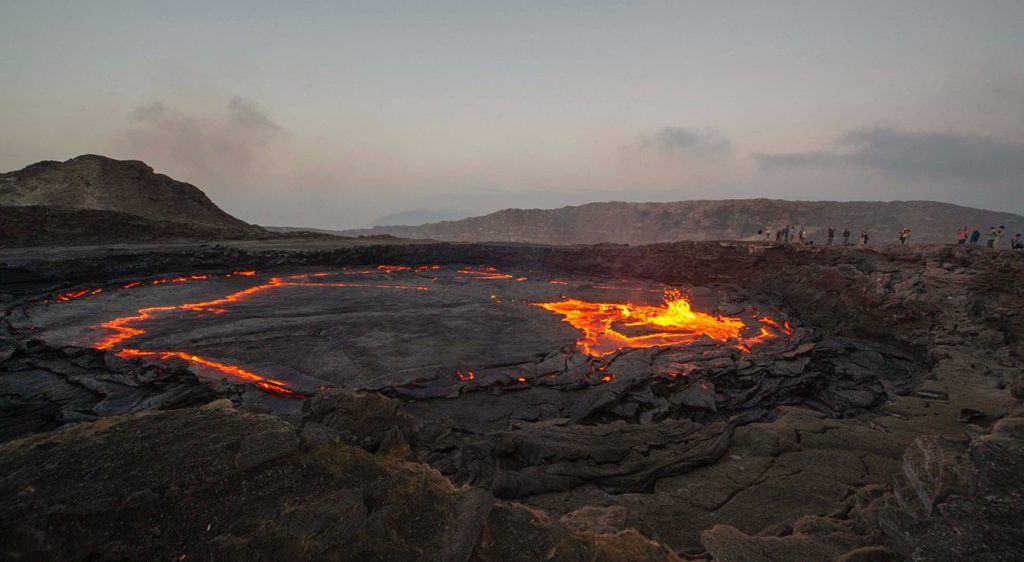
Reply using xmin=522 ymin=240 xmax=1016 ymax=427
xmin=0 ymin=155 xmax=267 ymax=246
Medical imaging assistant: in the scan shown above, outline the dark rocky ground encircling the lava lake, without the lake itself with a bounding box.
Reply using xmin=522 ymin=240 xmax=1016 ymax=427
xmin=0 ymin=244 xmax=1024 ymax=560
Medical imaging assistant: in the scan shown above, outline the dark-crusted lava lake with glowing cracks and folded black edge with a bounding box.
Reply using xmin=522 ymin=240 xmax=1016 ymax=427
xmin=20 ymin=255 xmax=924 ymax=489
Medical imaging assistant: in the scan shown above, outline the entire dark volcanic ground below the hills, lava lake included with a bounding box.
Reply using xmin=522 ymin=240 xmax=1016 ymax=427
xmin=0 ymin=238 xmax=1024 ymax=560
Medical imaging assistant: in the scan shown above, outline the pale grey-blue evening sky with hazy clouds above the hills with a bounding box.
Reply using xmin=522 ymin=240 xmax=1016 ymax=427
xmin=0 ymin=0 xmax=1024 ymax=228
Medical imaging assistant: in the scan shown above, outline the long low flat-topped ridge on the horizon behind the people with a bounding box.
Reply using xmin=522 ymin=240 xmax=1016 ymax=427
xmin=345 ymin=199 xmax=1024 ymax=244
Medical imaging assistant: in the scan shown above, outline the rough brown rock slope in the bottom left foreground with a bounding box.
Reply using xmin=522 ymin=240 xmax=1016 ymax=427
xmin=0 ymin=402 xmax=673 ymax=561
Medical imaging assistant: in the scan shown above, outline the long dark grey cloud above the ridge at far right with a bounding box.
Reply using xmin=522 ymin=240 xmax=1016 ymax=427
xmin=752 ymin=127 xmax=1024 ymax=180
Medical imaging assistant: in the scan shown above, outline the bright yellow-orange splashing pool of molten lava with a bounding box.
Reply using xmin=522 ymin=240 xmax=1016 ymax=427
xmin=534 ymin=290 xmax=788 ymax=357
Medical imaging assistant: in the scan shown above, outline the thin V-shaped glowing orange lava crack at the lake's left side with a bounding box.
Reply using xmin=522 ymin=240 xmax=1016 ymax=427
xmin=92 ymin=270 xmax=429 ymax=398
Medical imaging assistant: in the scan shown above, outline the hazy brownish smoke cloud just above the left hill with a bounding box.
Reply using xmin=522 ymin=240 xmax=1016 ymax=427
xmin=114 ymin=97 xmax=285 ymax=185
